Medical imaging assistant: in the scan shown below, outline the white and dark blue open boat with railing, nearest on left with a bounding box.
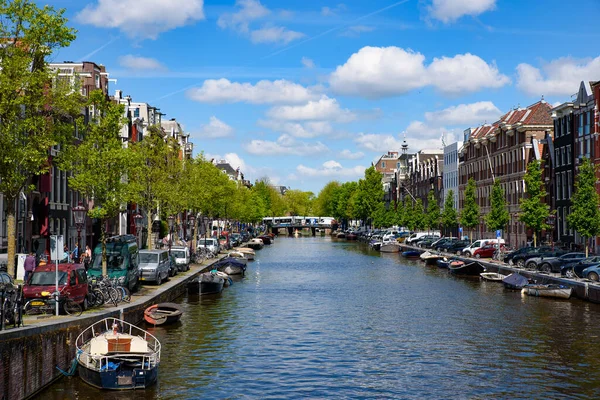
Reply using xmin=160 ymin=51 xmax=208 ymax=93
xmin=75 ymin=318 xmax=161 ymax=390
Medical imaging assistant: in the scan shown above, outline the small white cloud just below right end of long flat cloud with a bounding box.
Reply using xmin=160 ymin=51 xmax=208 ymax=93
xmin=267 ymin=95 xmax=356 ymax=122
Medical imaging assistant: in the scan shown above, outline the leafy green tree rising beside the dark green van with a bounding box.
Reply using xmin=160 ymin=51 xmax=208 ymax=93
xmin=58 ymin=90 xmax=133 ymax=275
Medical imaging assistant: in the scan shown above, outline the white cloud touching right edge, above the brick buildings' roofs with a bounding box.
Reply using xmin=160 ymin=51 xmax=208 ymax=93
xmin=517 ymin=56 xmax=600 ymax=96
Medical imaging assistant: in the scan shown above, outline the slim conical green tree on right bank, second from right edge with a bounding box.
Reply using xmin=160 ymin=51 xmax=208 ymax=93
xmin=519 ymin=160 xmax=550 ymax=247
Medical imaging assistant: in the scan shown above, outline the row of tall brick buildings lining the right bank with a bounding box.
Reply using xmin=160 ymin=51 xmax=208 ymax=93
xmin=375 ymin=81 xmax=600 ymax=250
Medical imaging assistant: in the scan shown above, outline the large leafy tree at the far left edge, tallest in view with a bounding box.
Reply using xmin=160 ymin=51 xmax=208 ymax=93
xmin=0 ymin=0 xmax=81 ymax=275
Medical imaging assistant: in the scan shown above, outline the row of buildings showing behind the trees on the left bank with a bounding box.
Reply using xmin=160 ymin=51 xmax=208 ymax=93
xmin=0 ymin=62 xmax=193 ymax=254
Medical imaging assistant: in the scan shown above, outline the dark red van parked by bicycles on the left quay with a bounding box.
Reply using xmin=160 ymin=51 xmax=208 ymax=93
xmin=23 ymin=263 xmax=88 ymax=309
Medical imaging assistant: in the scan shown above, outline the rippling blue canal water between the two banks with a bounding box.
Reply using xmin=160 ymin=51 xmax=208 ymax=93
xmin=39 ymin=237 xmax=600 ymax=399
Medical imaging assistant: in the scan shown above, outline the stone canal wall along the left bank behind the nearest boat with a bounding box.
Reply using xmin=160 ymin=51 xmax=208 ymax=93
xmin=0 ymin=260 xmax=216 ymax=400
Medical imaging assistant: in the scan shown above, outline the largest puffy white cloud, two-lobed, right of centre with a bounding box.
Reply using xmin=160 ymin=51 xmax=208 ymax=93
xmin=329 ymin=46 xmax=510 ymax=98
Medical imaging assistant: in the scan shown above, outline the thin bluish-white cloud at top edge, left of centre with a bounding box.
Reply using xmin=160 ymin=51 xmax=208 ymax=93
xmin=217 ymin=0 xmax=305 ymax=44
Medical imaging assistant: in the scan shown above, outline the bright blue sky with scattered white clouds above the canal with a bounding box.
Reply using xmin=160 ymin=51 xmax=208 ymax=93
xmin=40 ymin=0 xmax=600 ymax=194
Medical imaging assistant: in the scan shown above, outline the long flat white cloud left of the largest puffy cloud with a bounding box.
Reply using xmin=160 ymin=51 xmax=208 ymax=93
xmin=187 ymin=79 xmax=319 ymax=104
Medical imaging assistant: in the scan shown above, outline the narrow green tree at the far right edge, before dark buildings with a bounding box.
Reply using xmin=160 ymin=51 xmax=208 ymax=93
xmin=567 ymin=158 xmax=600 ymax=257
